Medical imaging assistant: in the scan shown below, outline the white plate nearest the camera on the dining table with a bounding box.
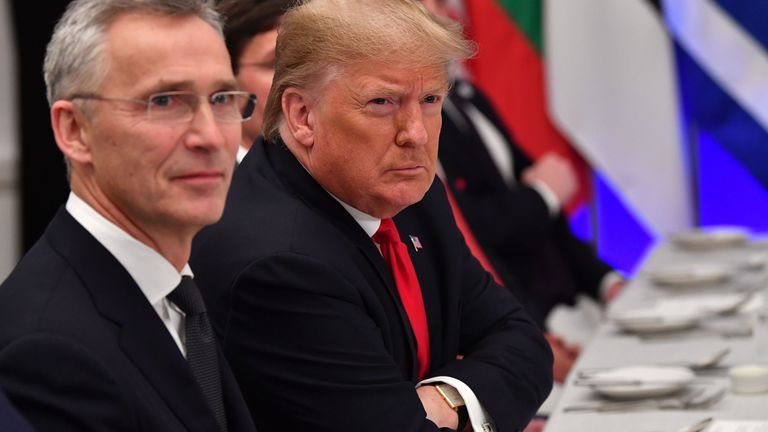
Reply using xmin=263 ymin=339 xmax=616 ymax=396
xmin=589 ymin=366 xmax=694 ymax=399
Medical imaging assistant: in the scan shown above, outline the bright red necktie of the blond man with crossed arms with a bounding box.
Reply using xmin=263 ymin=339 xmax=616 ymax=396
xmin=373 ymin=219 xmax=429 ymax=379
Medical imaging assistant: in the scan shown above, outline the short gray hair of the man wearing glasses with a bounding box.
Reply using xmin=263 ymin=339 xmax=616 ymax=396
xmin=43 ymin=0 xmax=223 ymax=105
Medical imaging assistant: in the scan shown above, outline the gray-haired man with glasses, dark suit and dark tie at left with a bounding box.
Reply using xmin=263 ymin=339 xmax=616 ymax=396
xmin=0 ymin=0 xmax=255 ymax=432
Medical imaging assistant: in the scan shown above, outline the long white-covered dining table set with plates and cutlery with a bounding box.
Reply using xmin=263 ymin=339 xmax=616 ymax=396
xmin=544 ymin=233 xmax=768 ymax=432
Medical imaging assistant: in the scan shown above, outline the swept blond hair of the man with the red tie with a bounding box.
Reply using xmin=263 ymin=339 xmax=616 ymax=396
xmin=264 ymin=0 xmax=475 ymax=140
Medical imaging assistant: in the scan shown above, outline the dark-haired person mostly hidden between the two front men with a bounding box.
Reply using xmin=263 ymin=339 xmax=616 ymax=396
xmin=218 ymin=0 xmax=295 ymax=163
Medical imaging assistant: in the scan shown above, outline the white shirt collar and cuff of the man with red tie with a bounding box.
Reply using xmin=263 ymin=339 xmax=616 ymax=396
xmin=338 ymin=199 xmax=495 ymax=432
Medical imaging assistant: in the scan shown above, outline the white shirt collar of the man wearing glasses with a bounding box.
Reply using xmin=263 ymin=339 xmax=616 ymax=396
xmin=66 ymin=192 xmax=192 ymax=305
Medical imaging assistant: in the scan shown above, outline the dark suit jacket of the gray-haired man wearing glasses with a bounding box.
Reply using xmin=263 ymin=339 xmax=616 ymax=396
xmin=0 ymin=209 xmax=255 ymax=432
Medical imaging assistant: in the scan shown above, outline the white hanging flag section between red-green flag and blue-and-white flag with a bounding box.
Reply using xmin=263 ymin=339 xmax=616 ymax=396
xmin=544 ymin=0 xmax=698 ymax=237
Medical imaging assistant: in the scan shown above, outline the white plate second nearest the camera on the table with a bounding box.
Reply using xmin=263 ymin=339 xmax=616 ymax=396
xmin=611 ymin=308 xmax=703 ymax=334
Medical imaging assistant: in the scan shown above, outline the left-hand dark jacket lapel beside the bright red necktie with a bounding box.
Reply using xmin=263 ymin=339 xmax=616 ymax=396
xmin=258 ymin=141 xmax=418 ymax=377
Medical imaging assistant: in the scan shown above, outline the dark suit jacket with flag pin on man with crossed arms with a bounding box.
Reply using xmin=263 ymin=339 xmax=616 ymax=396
xmin=191 ymin=140 xmax=552 ymax=432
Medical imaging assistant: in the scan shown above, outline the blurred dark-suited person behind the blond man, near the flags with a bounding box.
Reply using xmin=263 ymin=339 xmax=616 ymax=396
xmin=421 ymin=0 xmax=624 ymax=382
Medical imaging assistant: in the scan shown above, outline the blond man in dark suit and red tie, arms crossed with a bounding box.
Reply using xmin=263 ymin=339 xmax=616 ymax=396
xmin=192 ymin=0 xmax=552 ymax=432
